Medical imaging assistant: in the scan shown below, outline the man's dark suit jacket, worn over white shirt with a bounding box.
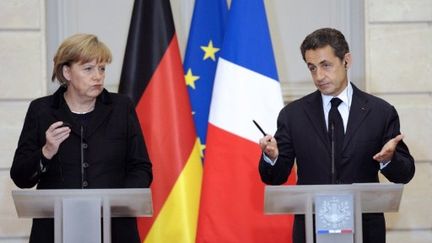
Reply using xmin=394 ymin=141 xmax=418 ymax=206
xmin=259 ymin=85 xmax=415 ymax=243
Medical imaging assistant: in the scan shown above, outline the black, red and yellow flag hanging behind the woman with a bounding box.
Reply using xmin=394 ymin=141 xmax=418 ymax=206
xmin=119 ymin=0 xmax=202 ymax=243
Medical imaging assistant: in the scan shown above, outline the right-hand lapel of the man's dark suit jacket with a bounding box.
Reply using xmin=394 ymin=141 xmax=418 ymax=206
xmin=342 ymin=85 xmax=371 ymax=151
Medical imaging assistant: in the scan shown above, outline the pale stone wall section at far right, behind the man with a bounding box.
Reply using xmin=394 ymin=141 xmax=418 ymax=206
xmin=365 ymin=0 xmax=432 ymax=240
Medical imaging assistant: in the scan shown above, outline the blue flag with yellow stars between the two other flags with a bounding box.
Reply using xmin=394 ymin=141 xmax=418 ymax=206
xmin=183 ymin=0 xmax=228 ymax=157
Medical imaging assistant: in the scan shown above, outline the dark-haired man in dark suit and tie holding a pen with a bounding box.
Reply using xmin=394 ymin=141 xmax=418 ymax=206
xmin=259 ymin=28 xmax=415 ymax=243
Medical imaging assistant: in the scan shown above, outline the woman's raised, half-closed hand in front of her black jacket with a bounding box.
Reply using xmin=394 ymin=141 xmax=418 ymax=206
xmin=42 ymin=121 xmax=71 ymax=159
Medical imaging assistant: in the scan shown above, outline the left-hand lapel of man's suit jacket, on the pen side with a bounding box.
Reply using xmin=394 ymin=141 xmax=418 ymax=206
xmin=304 ymin=90 xmax=330 ymax=151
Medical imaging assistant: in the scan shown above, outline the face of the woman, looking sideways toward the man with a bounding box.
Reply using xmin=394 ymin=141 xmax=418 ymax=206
xmin=63 ymin=60 xmax=106 ymax=100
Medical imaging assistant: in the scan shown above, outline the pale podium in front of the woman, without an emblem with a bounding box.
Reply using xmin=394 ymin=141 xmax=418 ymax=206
xmin=12 ymin=188 xmax=153 ymax=243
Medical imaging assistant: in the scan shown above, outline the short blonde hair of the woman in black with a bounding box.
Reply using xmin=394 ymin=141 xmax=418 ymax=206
xmin=51 ymin=34 xmax=112 ymax=85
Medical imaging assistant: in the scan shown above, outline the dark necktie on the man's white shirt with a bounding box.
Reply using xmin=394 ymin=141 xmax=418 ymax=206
xmin=328 ymin=97 xmax=345 ymax=183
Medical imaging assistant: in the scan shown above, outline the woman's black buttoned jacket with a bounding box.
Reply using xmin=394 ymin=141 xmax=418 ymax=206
xmin=10 ymin=87 xmax=152 ymax=243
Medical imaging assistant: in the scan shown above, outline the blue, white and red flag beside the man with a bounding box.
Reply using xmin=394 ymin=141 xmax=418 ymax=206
xmin=197 ymin=0 xmax=292 ymax=243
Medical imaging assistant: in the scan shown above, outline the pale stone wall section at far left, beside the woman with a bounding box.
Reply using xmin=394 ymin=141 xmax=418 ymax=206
xmin=0 ymin=0 xmax=47 ymax=243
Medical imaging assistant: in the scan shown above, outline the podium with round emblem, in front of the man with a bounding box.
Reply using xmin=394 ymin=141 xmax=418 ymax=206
xmin=264 ymin=183 xmax=403 ymax=243
